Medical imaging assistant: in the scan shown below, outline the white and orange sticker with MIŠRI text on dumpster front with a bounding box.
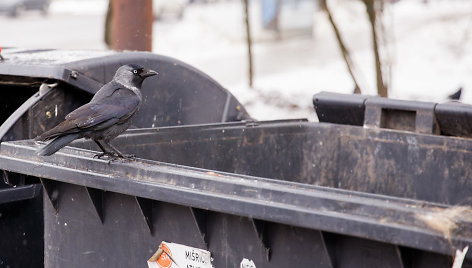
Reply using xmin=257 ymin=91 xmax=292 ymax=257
xmin=148 ymin=241 xmax=213 ymax=268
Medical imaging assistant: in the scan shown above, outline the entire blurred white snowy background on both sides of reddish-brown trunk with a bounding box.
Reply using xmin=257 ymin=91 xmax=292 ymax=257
xmin=0 ymin=0 xmax=472 ymax=120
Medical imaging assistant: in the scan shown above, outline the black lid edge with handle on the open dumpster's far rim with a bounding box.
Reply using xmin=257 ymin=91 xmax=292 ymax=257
xmin=313 ymin=92 xmax=472 ymax=138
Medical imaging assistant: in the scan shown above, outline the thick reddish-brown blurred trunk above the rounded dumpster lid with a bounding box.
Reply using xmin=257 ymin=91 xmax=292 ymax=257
xmin=105 ymin=0 xmax=154 ymax=51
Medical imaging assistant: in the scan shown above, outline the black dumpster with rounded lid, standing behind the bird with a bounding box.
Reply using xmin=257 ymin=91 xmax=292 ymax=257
xmin=0 ymin=48 xmax=249 ymax=267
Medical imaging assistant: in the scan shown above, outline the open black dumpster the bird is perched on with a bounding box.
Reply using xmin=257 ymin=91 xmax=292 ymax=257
xmin=0 ymin=82 xmax=472 ymax=267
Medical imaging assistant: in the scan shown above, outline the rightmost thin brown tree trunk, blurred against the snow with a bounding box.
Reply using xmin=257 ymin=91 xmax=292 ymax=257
xmin=362 ymin=0 xmax=388 ymax=97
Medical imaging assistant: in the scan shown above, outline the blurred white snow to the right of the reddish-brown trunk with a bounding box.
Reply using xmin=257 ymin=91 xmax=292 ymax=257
xmin=154 ymin=0 xmax=472 ymax=119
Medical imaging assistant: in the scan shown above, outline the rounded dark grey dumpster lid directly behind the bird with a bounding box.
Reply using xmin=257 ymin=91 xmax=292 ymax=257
xmin=0 ymin=48 xmax=250 ymax=140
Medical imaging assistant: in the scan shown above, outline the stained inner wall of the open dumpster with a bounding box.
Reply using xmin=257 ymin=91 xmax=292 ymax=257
xmin=73 ymin=120 xmax=472 ymax=205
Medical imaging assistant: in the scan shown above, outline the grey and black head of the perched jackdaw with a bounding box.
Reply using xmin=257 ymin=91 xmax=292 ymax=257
xmin=113 ymin=64 xmax=158 ymax=87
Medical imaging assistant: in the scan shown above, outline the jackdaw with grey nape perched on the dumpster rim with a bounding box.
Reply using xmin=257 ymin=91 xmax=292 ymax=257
xmin=35 ymin=64 xmax=158 ymax=158
